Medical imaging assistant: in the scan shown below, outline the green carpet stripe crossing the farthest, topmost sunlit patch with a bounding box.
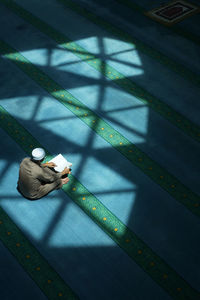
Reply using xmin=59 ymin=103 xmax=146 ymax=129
xmin=0 ymin=0 xmax=200 ymax=146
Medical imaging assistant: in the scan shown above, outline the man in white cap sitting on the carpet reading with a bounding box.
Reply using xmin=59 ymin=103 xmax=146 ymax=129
xmin=17 ymin=148 xmax=70 ymax=200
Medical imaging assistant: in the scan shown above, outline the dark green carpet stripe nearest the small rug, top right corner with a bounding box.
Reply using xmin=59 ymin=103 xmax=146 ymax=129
xmin=115 ymin=0 xmax=200 ymax=45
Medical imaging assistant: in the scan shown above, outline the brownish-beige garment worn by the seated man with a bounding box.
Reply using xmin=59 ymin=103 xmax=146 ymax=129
xmin=18 ymin=158 xmax=62 ymax=199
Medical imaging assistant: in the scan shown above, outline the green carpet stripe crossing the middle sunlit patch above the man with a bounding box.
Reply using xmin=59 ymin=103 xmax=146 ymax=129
xmin=0 ymin=41 xmax=200 ymax=216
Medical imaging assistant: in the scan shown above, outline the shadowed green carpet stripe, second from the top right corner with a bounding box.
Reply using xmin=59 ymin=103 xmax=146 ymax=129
xmin=57 ymin=0 xmax=200 ymax=87
